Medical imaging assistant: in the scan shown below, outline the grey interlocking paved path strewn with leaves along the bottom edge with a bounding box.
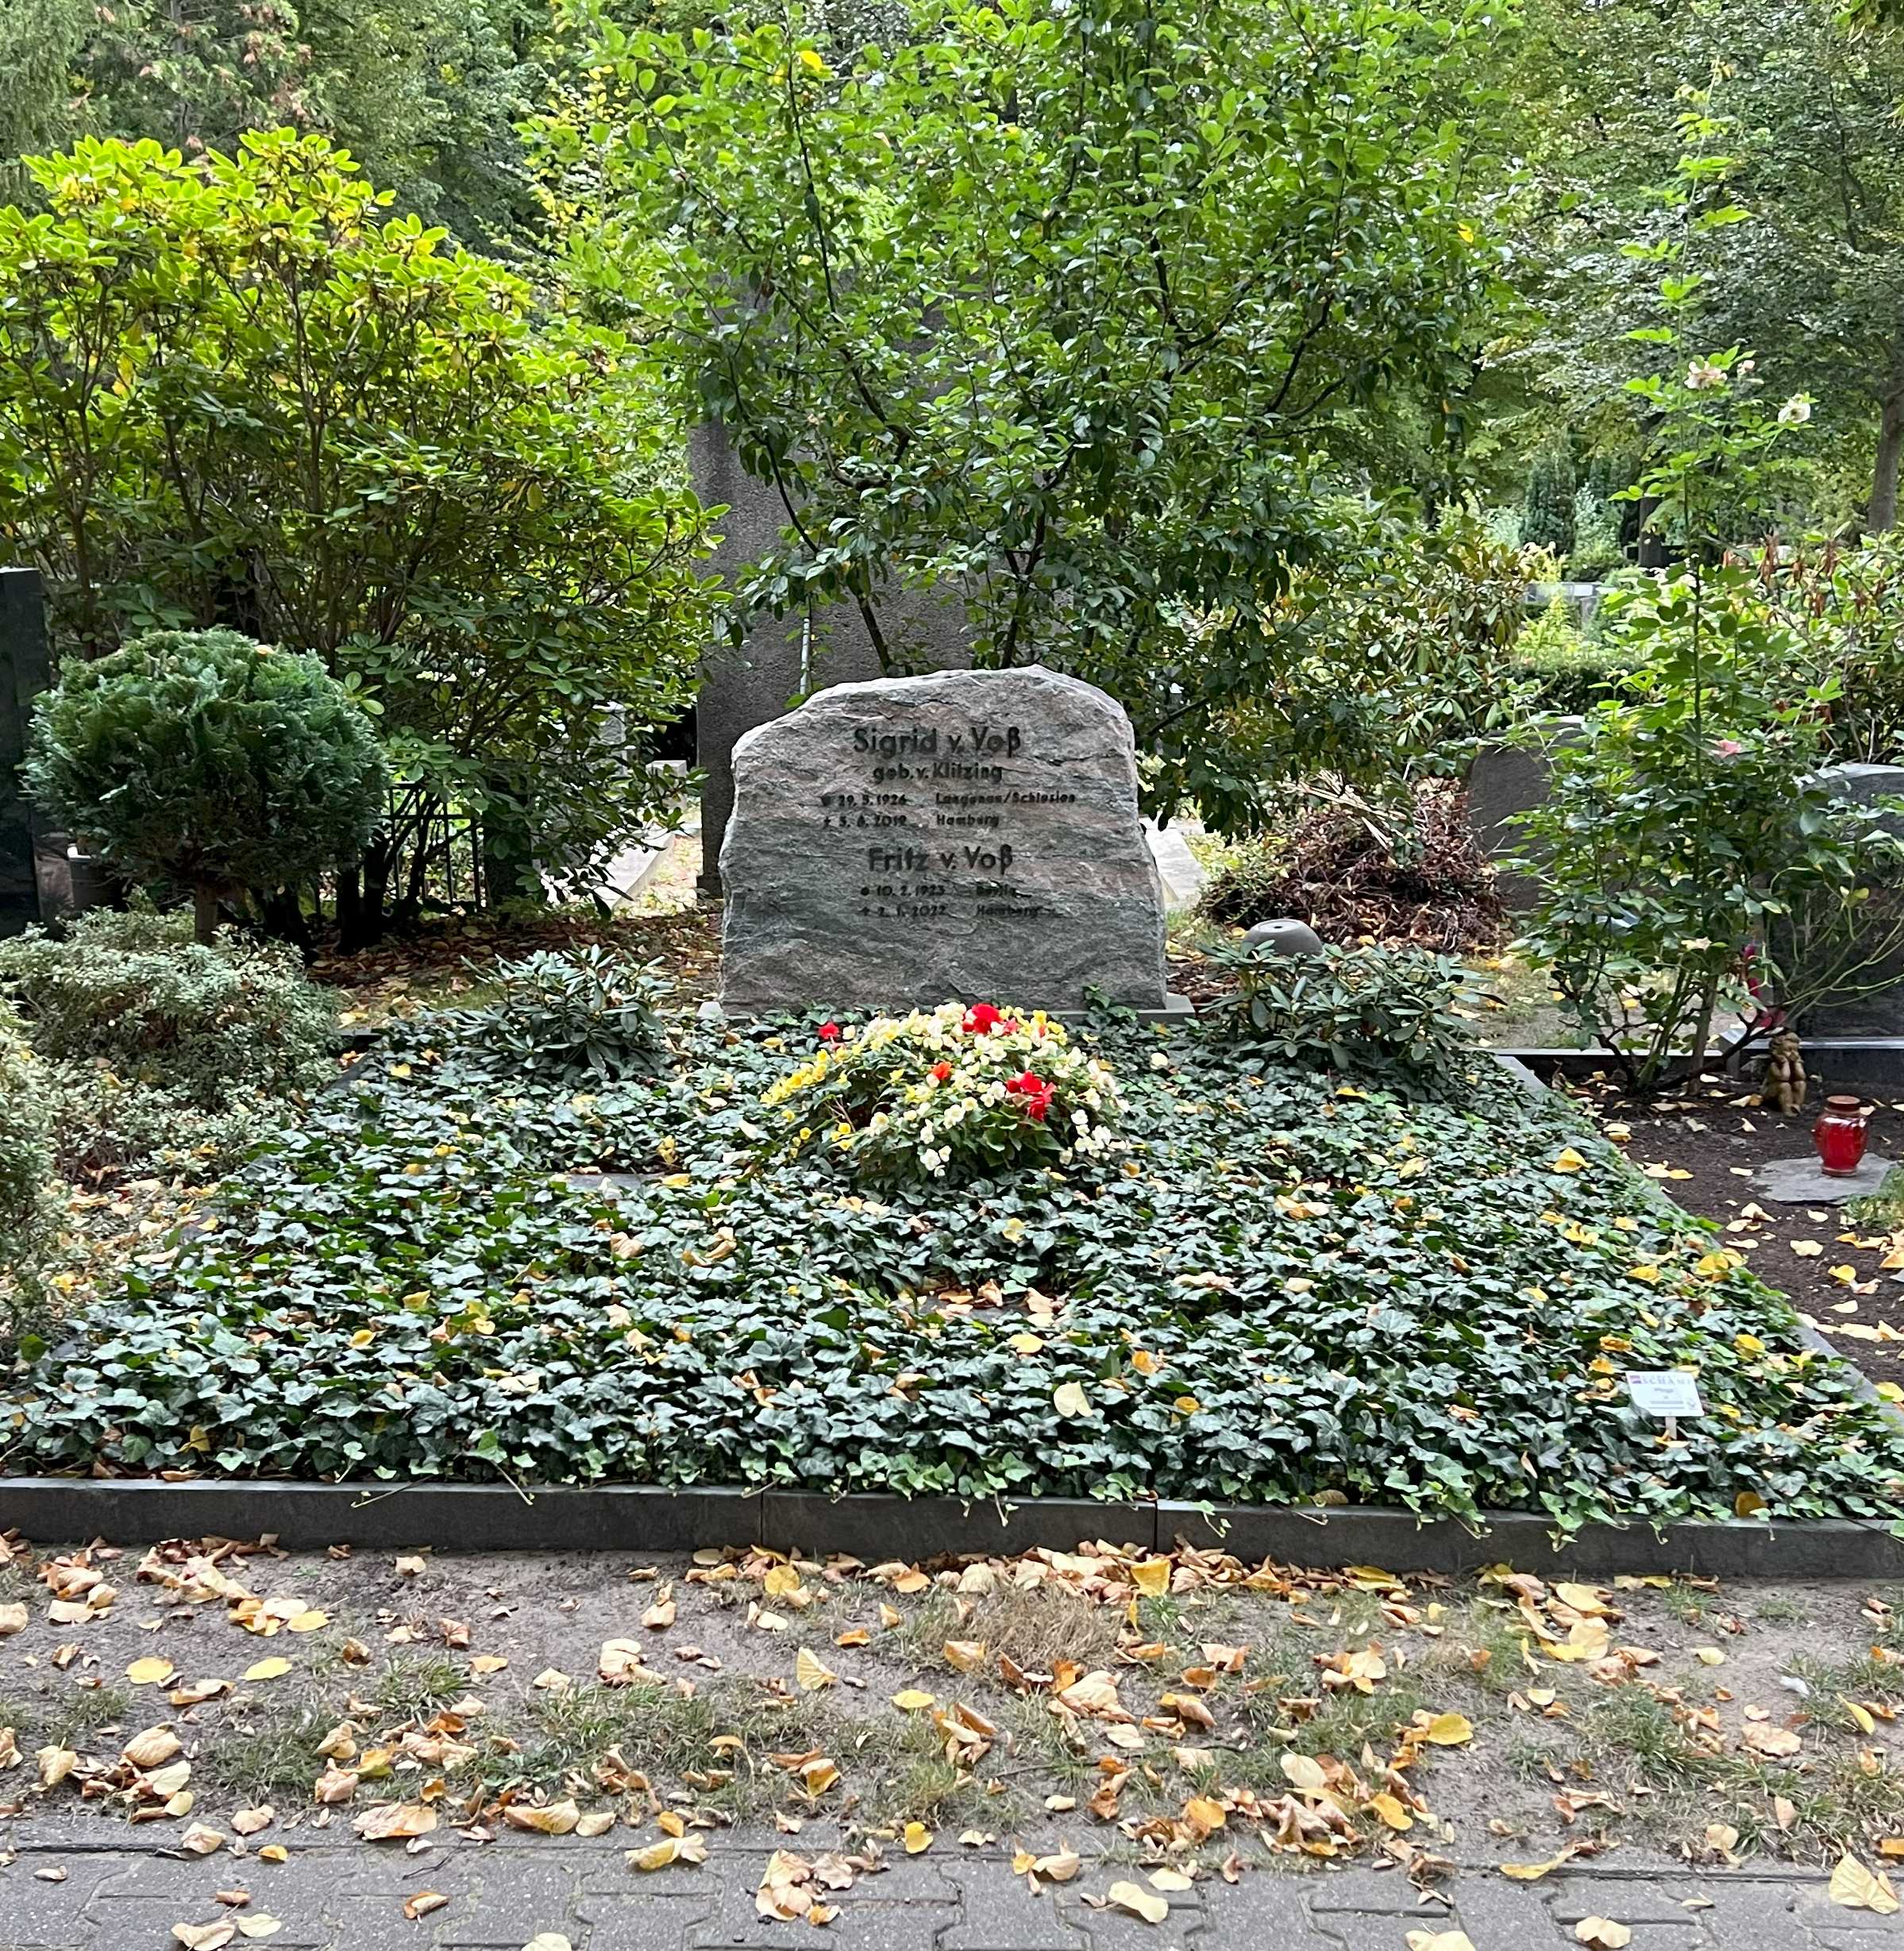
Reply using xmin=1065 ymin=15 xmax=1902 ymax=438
xmin=0 ymin=1824 xmax=1904 ymax=1951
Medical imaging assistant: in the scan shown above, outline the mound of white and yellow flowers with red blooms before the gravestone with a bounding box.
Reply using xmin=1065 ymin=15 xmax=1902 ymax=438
xmin=761 ymin=1003 xmax=1124 ymax=1178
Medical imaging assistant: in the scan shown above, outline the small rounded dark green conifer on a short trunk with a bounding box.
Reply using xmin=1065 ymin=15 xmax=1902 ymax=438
xmin=21 ymin=630 xmax=386 ymax=943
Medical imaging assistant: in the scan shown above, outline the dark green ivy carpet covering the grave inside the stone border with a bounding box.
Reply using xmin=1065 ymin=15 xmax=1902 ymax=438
xmin=14 ymin=1019 xmax=1904 ymax=1525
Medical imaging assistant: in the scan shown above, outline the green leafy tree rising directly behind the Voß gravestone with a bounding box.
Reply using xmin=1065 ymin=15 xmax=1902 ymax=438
xmin=541 ymin=0 xmax=1494 ymax=825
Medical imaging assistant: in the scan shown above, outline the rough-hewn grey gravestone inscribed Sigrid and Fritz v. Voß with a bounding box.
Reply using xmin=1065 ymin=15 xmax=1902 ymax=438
xmin=720 ymin=667 xmax=1166 ymax=1011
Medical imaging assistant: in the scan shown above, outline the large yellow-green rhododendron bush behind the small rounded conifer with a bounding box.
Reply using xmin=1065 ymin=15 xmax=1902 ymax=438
xmin=0 ymin=131 xmax=704 ymax=939
